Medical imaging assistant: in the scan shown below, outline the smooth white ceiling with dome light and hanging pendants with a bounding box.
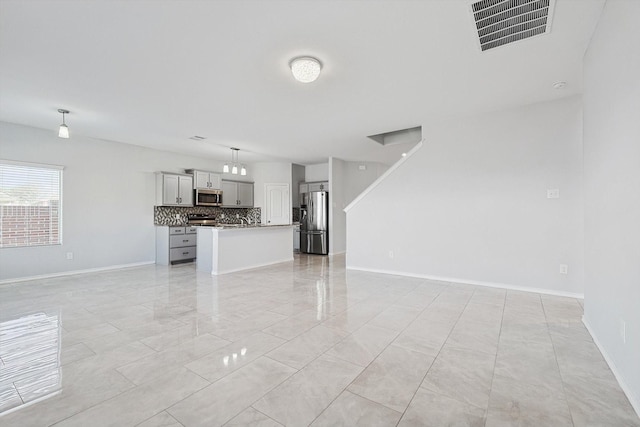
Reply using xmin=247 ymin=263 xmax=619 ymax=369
xmin=0 ymin=0 xmax=604 ymax=164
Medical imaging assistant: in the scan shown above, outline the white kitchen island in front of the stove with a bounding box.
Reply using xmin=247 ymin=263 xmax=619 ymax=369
xmin=196 ymin=225 xmax=293 ymax=276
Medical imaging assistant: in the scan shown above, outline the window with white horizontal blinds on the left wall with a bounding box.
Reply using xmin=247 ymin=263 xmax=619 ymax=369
xmin=0 ymin=160 xmax=62 ymax=248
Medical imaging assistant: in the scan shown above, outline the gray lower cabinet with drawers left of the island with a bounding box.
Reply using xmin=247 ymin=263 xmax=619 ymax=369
xmin=156 ymin=225 xmax=197 ymax=265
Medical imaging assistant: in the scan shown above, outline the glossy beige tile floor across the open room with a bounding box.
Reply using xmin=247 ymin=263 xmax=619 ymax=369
xmin=0 ymin=255 xmax=640 ymax=427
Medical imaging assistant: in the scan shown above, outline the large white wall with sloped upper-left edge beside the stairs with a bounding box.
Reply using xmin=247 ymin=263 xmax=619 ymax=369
xmin=347 ymin=97 xmax=583 ymax=295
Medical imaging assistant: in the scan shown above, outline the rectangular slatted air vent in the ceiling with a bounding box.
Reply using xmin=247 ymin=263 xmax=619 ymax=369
xmin=471 ymin=0 xmax=555 ymax=51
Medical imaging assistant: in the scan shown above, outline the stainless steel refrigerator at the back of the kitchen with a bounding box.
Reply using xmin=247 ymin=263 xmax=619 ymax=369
xmin=300 ymin=191 xmax=329 ymax=255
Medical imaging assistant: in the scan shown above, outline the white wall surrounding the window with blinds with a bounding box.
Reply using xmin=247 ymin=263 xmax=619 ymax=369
xmin=0 ymin=122 xmax=251 ymax=280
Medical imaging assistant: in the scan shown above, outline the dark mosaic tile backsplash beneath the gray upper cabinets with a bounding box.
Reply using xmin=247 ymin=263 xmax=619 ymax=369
xmin=153 ymin=206 xmax=261 ymax=225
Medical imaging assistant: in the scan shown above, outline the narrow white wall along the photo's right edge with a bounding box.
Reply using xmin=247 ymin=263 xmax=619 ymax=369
xmin=584 ymin=0 xmax=640 ymax=413
